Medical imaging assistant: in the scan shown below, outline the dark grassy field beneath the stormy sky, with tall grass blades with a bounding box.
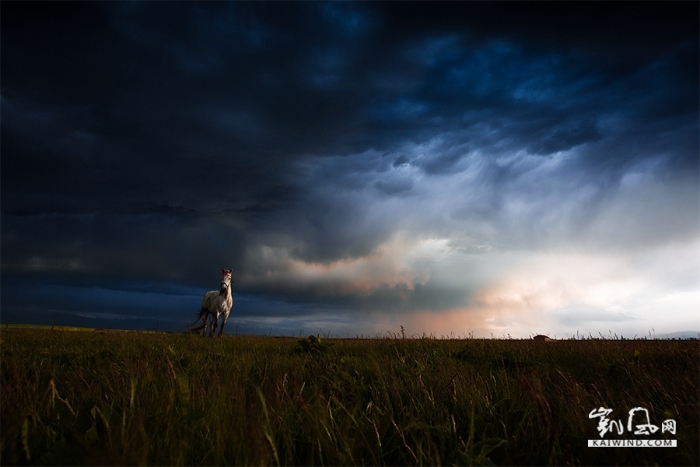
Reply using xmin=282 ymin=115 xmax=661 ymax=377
xmin=0 ymin=328 xmax=700 ymax=465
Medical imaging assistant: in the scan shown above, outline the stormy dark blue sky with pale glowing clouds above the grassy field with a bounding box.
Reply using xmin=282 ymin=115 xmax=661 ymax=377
xmin=0 ymin=2 xmax=700 ymax=337
